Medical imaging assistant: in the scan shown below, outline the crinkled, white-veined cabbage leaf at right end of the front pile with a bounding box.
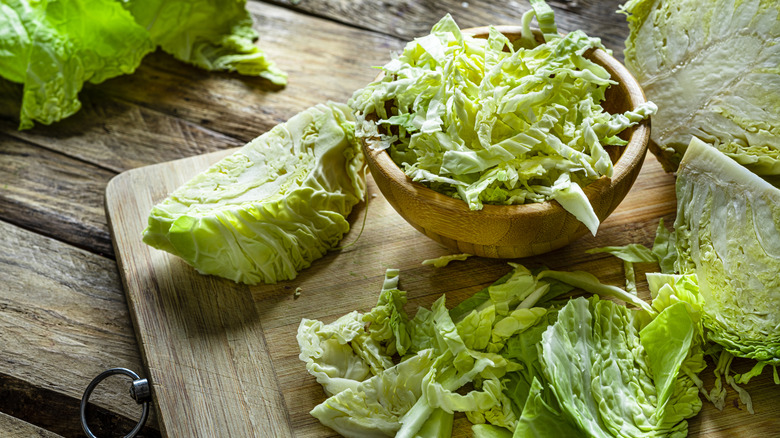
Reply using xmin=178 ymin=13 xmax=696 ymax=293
xmin=540 ymin=297 xmax=701 ymax=437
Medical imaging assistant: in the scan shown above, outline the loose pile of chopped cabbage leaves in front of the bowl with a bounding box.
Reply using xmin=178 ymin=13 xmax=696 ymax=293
xmin=298 ymin=265 xmax=704 ymax=437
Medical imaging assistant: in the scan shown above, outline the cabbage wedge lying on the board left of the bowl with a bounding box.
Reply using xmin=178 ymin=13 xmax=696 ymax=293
xmin=143 ymin=103 xmax=365 ymax=284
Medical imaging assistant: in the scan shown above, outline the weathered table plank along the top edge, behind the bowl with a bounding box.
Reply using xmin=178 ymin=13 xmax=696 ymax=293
xmin=268 ymin=0 xmax=628 ymax=60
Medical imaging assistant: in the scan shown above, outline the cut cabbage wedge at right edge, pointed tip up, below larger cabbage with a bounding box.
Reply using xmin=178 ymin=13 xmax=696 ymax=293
xmin=675 ymin=138 xmax=780 ymax=367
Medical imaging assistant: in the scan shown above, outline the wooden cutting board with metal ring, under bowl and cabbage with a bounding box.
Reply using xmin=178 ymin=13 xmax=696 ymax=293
xmin=106 ymin=150 xmax=780 ymax=438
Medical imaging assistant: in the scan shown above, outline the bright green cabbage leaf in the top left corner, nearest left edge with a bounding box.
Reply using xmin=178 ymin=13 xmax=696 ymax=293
xmin=0 ymin=0 xmax=154 ymax=129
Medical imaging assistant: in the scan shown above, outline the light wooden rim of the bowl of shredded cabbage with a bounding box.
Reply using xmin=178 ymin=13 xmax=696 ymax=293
xmin=360 ymin=25 xmax=650 ymax=220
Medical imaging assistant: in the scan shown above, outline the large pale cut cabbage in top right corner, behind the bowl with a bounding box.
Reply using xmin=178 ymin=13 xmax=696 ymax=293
xmin=622 ymin=0 xmax=780 ymax=175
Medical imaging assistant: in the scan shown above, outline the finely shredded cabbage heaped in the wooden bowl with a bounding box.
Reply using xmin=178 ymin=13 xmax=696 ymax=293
xmin=349 ymin=0 xmax=655 ymax=234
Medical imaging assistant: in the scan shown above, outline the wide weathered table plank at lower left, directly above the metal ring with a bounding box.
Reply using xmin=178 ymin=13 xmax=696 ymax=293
xmin=0 ymin=221 xmax=155 ymax=430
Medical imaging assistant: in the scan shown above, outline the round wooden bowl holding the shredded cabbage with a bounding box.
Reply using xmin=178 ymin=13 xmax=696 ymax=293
xmin=361 ymin=26 xmax=650 ymax=258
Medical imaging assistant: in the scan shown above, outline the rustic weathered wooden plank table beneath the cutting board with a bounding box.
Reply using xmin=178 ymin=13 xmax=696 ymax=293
xmin=0 ymin=0 xmax=780 ymax=437
